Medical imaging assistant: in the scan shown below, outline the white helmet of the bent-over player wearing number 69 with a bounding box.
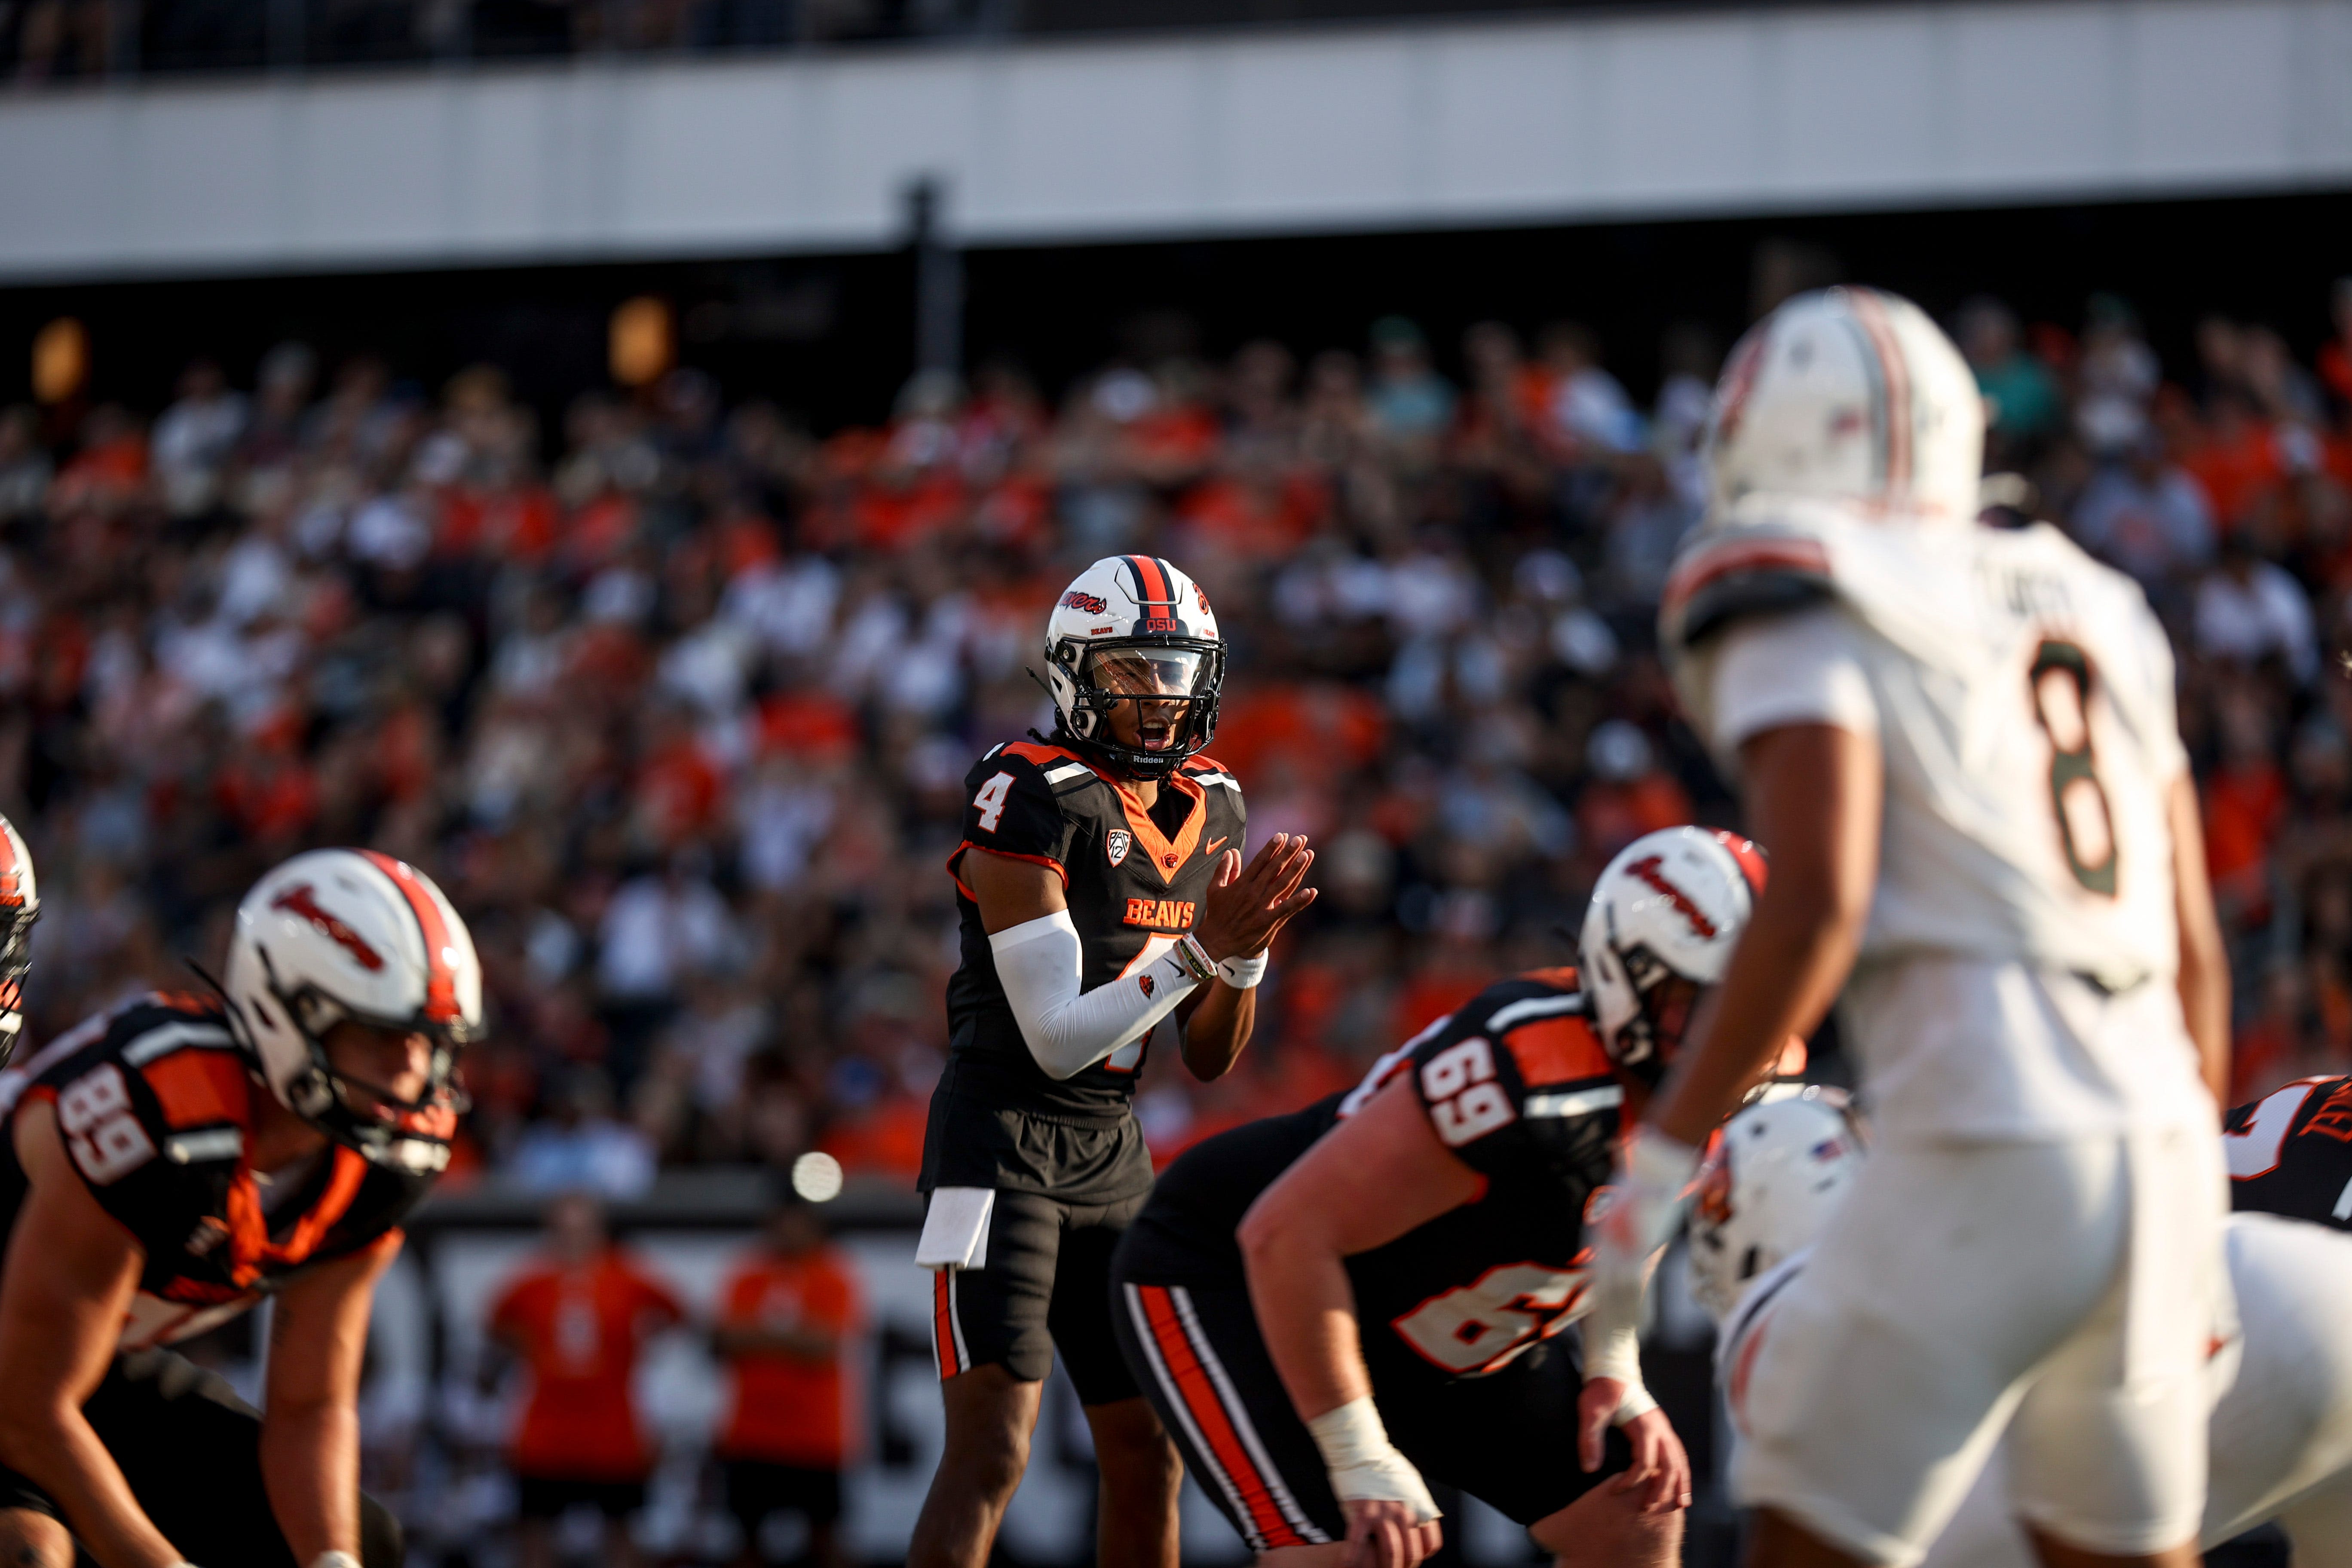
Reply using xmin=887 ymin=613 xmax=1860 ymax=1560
xmin=1576 ymin=827 xmax=1764 ymax=1088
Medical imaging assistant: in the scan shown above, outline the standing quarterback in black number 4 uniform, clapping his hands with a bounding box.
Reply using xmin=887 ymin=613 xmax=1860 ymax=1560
xmin=908 ymin=555 xmax=1315 ymax=1568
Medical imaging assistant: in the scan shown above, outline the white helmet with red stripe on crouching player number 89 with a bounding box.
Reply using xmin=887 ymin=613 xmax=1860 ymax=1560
xmin=221 ymin=848 xmax=482 ymax=1173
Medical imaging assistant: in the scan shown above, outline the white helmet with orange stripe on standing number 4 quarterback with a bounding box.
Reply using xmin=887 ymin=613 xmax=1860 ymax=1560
xmin=1044 ymin=555 xmax=1225 ymax=778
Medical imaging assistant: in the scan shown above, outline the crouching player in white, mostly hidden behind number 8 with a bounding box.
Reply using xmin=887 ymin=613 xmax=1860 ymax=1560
xmin=1691 ymin=1091 xmax=2352 ymax=1568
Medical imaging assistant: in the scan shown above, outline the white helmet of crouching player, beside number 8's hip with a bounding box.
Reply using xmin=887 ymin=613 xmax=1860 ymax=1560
xmin=1691 ymin=1086 xmax=1865 ymax=1321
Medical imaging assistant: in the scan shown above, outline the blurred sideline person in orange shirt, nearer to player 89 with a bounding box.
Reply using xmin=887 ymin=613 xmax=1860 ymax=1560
xmin=489 ymin=1194 xmax=687 ymax=1568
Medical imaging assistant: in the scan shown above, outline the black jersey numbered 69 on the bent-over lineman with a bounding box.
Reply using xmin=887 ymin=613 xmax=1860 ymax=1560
xmin=1122 ymin=968 xmax=1623 ymax=1382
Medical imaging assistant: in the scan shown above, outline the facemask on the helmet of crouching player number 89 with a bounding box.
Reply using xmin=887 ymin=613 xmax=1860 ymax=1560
xmin=247 ymin=952 xmax=475 ymax=1176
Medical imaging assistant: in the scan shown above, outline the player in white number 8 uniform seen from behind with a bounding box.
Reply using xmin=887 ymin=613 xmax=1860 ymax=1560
xmin=1597 ymin=289 xmax=2230 ymax=1568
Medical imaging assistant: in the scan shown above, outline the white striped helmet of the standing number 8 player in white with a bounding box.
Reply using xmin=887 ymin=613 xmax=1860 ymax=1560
xmin=1708 ymin=289 xmax=1985 ymax=522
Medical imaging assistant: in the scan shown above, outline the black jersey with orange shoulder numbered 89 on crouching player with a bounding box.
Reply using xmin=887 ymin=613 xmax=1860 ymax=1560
xmin=0 ymin=994 xmax=433 ymax=1349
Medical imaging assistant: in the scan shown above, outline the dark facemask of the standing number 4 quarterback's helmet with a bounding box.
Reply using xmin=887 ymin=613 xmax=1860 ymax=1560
xmin=1047 ymin=637 xmax=1225 ymax=778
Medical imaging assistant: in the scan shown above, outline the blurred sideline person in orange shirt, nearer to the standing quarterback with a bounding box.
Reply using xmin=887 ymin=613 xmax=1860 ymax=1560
xmin=710 ymin=1197 xmax=866 ymax=1568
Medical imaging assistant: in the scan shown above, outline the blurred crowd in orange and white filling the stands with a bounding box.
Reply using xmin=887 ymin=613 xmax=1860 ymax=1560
xmin=14 ymin=279 xmax=2352 ymax=1197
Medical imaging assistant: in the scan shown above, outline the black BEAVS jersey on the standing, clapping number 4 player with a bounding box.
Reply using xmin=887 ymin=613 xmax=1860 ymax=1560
xmin=922 ymin=741 xmax=1246 ymax=1201
